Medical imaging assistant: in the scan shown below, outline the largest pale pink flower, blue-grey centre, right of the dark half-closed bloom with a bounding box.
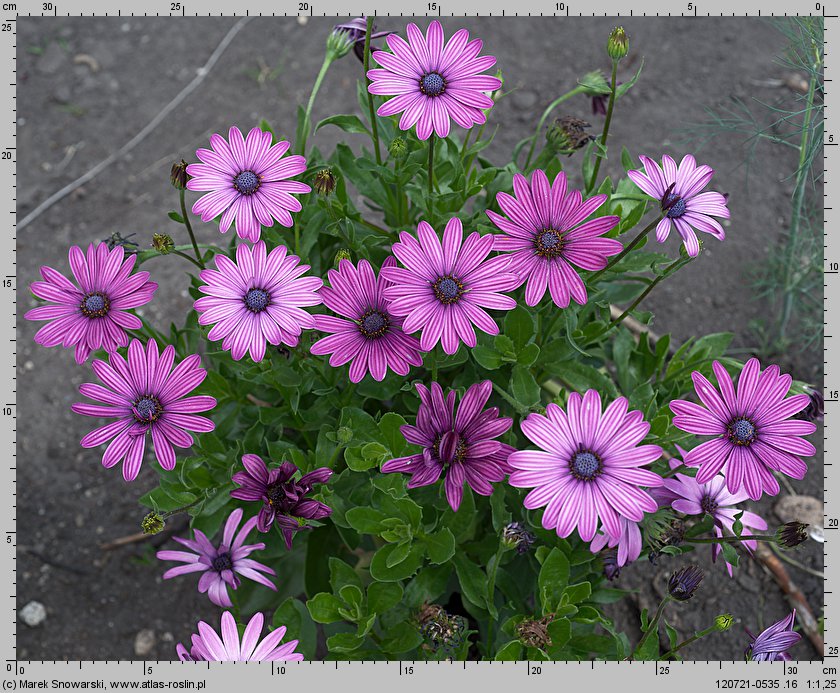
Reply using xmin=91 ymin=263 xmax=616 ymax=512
xmin=509 ymin=390 xmax=662 ymax=541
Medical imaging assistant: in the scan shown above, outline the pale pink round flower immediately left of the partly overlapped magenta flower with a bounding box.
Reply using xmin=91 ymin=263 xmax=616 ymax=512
xmin=195 ymin=241 xmax=323 ymax=361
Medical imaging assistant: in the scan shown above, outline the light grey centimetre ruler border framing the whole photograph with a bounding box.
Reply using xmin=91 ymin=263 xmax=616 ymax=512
xmin=0 ymin=0 xmax=840 ymax=693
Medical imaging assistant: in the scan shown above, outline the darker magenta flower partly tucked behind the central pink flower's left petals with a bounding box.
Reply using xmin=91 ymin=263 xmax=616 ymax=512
xmin=311 ymin=257 xmax=423 ymax=383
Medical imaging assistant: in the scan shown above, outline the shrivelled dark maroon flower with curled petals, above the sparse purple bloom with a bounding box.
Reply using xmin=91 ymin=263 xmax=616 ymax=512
xmin=230 ymin=455 xmax=332 ymax=549
